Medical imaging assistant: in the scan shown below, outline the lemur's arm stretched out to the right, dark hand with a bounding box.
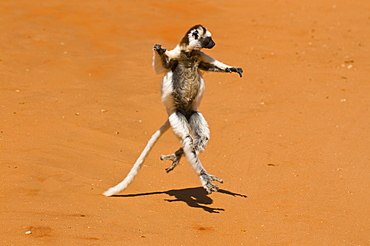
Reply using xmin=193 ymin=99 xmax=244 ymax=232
xmin=199 ymin=52 xmax=243 ymax=77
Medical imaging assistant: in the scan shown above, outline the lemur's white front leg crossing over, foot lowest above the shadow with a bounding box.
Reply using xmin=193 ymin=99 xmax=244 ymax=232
xmin=169 ymin=112 xmax=223 ymax=193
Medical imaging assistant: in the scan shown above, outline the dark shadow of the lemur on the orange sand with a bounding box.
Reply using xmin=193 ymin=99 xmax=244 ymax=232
xmin=113 ymin=187 xmax=247 ymax=213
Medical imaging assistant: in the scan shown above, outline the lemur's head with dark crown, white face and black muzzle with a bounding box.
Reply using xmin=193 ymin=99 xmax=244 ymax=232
xmin=179 ymin=25 xmax=215 ymax=51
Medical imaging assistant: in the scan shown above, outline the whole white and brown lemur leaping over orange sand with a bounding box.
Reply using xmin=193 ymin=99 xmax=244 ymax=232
xmin=103 ymin=25 xmax=243 ymax=196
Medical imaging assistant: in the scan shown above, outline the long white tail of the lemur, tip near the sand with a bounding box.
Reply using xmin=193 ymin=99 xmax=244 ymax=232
xmin=103 ymin=121 xmax=170 ymax=196
